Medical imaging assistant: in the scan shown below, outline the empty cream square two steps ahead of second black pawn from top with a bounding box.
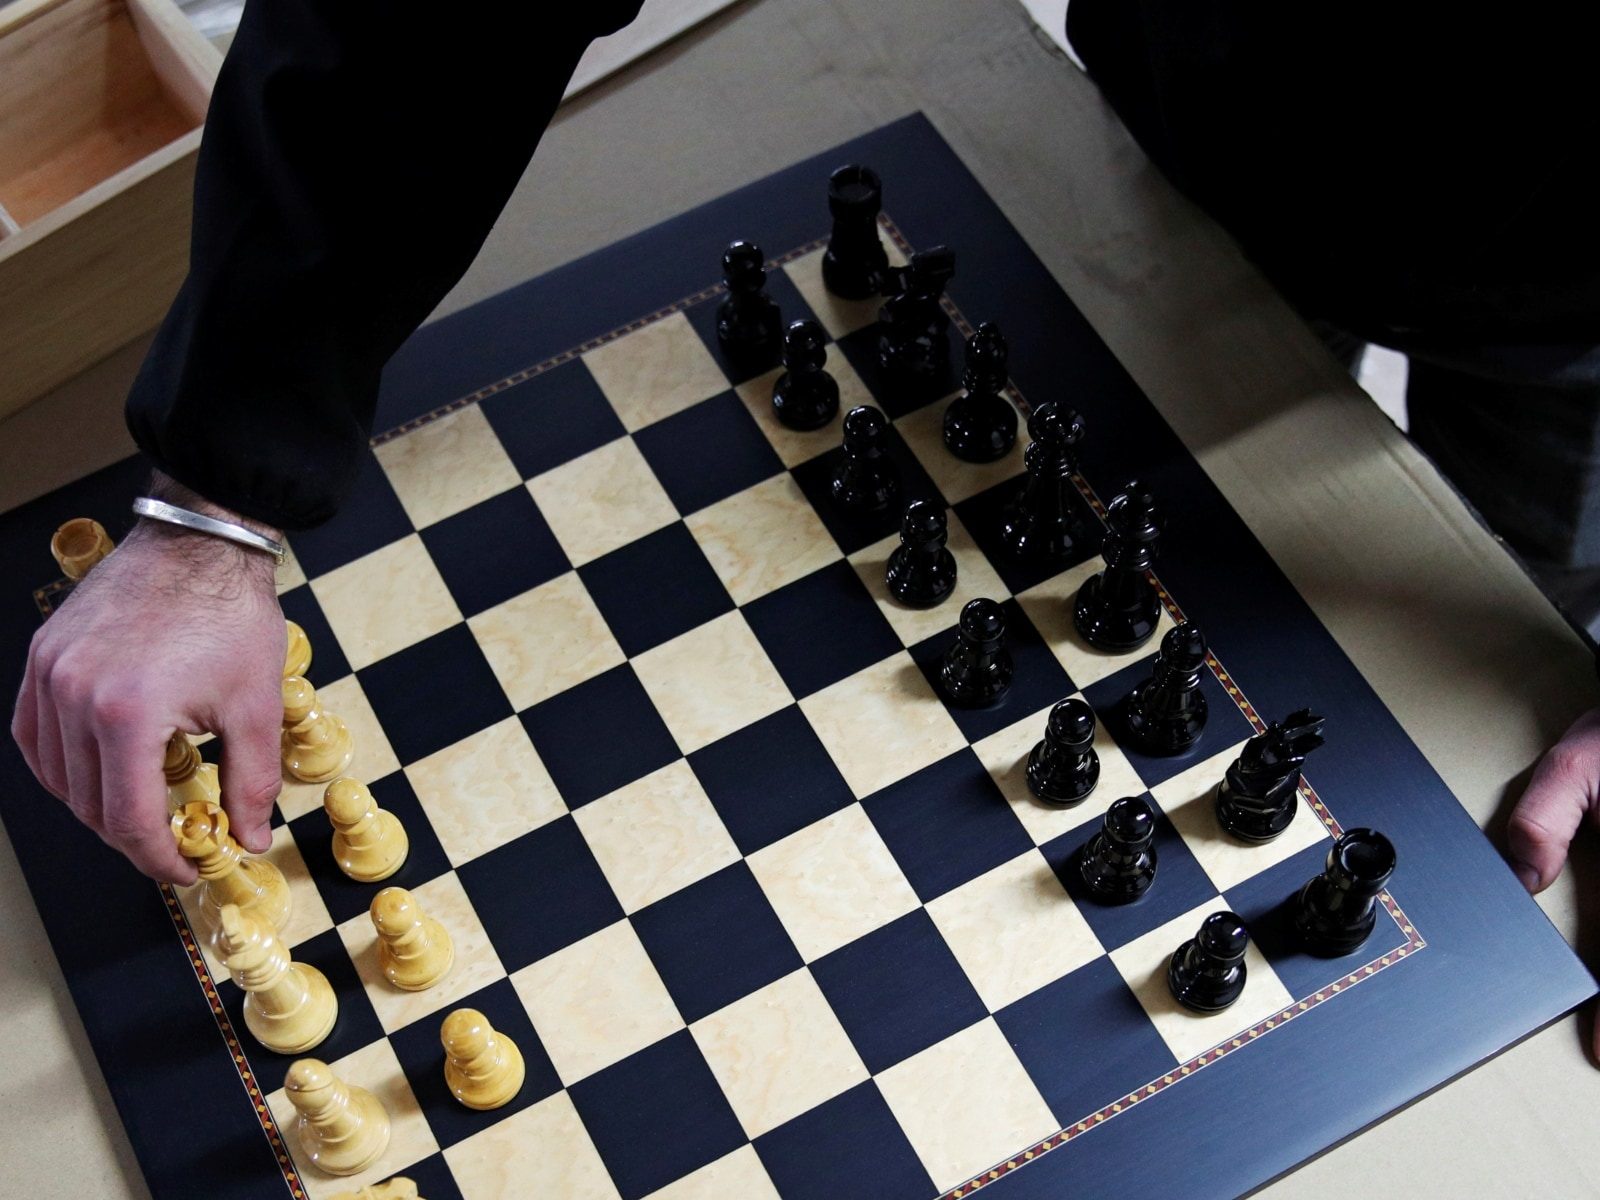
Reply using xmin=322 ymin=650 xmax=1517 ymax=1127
xmin=528 ymin=437 xmax=678 ymax=566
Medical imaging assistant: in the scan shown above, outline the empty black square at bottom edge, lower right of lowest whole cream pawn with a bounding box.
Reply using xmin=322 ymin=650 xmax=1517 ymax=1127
xmin=568 ymin=1029 xmax=746 ymax=1200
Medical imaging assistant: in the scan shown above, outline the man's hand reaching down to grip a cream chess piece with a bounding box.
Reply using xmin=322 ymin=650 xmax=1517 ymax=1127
xmin=11 ymin=477 xmax=285 ymax=883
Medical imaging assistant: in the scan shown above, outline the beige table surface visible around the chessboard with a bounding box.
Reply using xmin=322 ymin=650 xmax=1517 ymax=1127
xmin=0 ymin=0 xmax=1600 ymax=1200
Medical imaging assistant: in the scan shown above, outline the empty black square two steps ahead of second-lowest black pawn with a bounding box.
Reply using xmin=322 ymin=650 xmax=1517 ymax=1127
xmin=811 ymin=909 xmax=989 ymax=1075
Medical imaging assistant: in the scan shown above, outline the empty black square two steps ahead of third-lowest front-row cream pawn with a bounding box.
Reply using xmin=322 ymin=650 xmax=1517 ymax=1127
xmin=522 ymin=662 xmax=678 ymax=808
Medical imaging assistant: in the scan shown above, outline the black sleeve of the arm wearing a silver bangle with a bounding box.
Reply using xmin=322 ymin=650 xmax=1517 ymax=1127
xmin=128 ymin=0 xmax=642 ymax=530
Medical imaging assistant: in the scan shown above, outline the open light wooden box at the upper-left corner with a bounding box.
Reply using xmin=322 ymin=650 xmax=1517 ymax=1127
xmin=0 ymin=0 xmax=222 ymax=418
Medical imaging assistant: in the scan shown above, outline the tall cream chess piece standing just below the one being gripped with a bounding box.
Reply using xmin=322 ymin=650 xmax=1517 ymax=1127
xmin=216 ymin=904 xmax=339 ymax=1054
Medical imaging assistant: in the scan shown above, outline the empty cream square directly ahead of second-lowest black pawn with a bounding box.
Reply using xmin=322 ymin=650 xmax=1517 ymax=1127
xmin=928 ymin=850 xmax=1102 ymax=1013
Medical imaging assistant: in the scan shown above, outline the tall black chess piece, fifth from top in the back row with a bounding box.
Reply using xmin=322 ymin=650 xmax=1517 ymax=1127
xmin=1072 ymin=480 xmax=1162 ymax=651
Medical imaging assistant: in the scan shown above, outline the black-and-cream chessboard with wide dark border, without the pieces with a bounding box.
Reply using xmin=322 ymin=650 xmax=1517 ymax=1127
xmin=0 ymin=117 xmax=1594 ymax=1200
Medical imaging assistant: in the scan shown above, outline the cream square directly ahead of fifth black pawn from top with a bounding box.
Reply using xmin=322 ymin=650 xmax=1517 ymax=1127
xmin=800 ymin=650 xmax=966 ymax=800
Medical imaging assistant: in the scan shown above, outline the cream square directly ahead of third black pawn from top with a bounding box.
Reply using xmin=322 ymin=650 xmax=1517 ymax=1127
xmin=683 ymin=472 xmax=842 ymax=605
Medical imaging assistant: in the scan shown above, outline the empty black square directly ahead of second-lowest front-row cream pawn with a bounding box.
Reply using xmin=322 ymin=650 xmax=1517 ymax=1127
xmin=456 ymin=816 xmax=622 ymax=971
